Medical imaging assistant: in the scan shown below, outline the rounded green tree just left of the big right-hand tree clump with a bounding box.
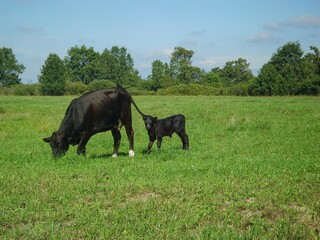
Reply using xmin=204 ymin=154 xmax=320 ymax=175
xmin=220 ymin=58 xmax=253 ymax=86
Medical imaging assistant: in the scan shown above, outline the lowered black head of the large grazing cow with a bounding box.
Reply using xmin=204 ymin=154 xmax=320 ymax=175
xmin=43 ymin=132 xmax=69 ymax=157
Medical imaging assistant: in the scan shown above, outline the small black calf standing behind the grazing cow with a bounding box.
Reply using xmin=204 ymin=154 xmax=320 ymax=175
xmin=142 ymin=114 xmax=189 ymax=154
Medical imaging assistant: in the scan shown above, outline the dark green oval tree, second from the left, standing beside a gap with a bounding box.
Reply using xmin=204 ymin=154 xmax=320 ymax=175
xmin=38 ymin=53 xmax=66 ymax=96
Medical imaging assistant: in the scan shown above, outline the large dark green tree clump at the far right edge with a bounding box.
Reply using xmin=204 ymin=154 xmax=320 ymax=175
xmin=251 ymin=42 xmax=319 ymax=95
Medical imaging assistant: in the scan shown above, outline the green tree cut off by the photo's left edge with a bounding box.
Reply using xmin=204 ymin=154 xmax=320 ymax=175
xmin=0 ymin=47 xmax=25 ymax=86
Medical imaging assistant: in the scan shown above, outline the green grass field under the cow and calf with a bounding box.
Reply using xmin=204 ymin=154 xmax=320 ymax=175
xmin=0 ymin=96 xmax=320 ymax=239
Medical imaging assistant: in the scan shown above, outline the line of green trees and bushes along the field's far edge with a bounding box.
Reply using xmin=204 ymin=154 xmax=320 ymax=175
xmin=0 ymin=42 xmax=320 ymax=96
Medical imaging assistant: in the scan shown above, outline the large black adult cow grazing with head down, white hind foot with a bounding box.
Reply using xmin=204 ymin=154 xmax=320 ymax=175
xmin=43 ymin=87 xmax=144 ymax=157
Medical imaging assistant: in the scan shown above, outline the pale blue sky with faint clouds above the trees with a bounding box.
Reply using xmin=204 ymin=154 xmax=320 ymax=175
xmin=0 ymin=0 xmax=320 ymax=83
